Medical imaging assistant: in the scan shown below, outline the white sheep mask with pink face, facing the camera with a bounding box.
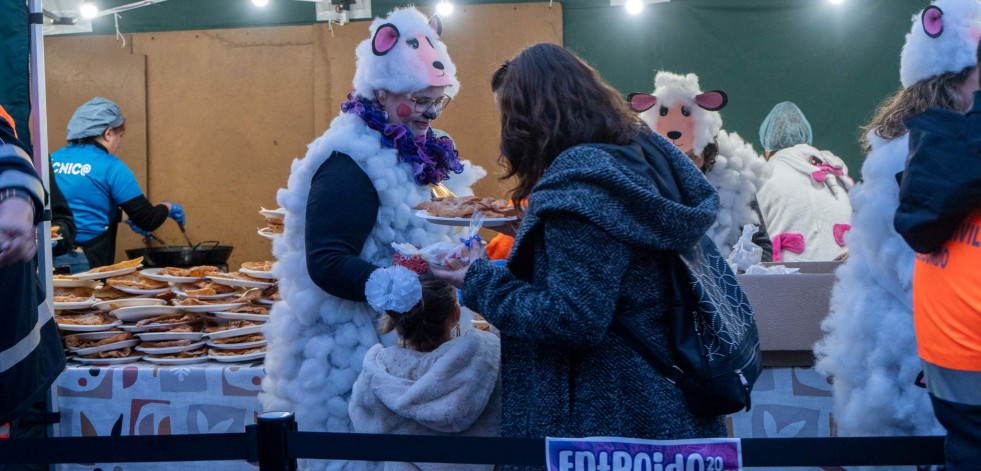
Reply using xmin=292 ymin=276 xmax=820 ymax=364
xmin=629 ymin=72 xmax=729 ymax=155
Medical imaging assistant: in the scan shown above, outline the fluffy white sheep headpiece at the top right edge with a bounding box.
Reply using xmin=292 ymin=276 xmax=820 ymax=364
xmin=899 ymin=0 xmax=981 ymax=88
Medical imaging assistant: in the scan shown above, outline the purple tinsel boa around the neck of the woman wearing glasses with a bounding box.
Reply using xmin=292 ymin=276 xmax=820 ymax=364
xmin=341 ymin=95 xmax=463 ymax=186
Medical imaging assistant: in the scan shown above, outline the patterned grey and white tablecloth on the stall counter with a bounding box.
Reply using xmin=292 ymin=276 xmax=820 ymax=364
xmin=56 ymin=363 xmax=841 ymax=471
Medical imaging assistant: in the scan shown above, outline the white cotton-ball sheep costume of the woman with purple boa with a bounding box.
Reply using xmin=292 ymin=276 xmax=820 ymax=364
xmin=259 ymin=8 xmax=486 ymax=469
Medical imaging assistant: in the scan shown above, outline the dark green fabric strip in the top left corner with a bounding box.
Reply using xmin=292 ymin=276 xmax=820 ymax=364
xmin=0 ymin=0 xmax=31 ymax=148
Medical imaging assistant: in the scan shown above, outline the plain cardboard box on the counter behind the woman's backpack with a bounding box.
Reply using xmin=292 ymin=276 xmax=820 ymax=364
xmin=737 ymin=262 xmax=841 ymax=358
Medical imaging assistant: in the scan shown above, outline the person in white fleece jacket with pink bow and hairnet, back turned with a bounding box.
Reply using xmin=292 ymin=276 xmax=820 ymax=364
xmin=756 ymin=101 xmax=855 ymax=262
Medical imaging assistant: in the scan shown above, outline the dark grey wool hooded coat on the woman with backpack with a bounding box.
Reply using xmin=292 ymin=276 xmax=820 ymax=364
xmin=462 ymin=133 xmax=725 ymax=469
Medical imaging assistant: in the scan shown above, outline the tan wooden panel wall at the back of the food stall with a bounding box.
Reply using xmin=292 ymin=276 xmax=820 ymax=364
xmin=47 ymin=3 xmax=562 ymax=268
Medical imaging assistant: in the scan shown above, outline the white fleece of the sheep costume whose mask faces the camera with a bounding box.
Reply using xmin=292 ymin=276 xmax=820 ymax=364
xmin=631 ymin=71 xmax=766 ymax=256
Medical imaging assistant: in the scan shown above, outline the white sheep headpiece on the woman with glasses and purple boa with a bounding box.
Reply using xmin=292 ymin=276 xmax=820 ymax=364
xmin=354 ymin=8 xmax=460 ymax=100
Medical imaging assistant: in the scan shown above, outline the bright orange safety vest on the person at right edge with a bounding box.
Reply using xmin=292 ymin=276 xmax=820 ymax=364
xmin=913 ymin=210 xmax=981 ymax=371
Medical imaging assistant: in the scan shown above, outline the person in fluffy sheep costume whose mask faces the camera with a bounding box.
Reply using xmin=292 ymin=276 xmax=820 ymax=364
xmin=630 ymin=71 xmax=765 ymax=256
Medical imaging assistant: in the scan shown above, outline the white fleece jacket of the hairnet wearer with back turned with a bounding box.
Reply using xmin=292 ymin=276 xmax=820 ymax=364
xmin=756 ymin=144 xmax=854 ymax=262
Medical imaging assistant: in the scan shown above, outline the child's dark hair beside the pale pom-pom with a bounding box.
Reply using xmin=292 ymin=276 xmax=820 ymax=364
xmin=378 ymin=270 xmax=457 ymax=352
